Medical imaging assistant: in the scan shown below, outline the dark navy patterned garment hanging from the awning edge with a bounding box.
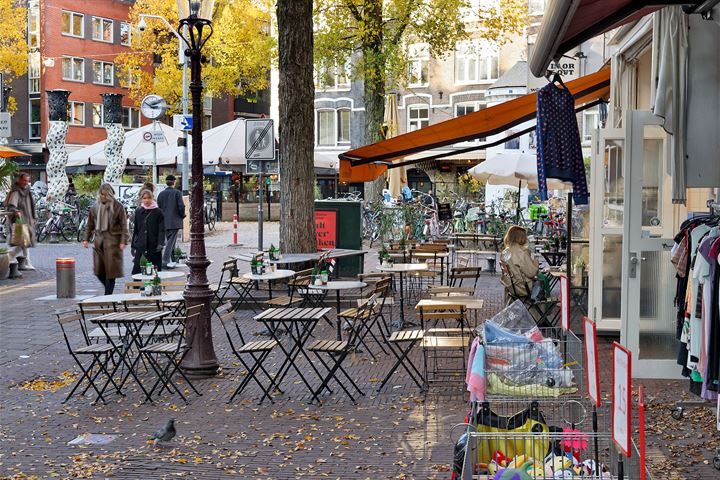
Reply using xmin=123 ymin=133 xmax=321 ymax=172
xmin=536 ymin=83 xmax=590 ymax=205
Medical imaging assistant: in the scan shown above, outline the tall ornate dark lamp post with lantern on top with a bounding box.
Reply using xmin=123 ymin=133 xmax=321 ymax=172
xmin=177 ymin=0 xmax=219 ymax=376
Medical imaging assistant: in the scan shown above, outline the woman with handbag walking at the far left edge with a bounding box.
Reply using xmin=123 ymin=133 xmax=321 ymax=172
xmin=5 ymin=172 xmax=37 ymax=278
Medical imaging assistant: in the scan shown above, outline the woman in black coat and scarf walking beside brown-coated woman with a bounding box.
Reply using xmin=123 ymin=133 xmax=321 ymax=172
xmin=131 ymin=190 xmax=165 ymax=275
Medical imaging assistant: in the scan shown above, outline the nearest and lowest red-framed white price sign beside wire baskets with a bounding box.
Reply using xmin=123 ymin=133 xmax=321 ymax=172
xmin=612 ymin=342 xmax=632 ymax=458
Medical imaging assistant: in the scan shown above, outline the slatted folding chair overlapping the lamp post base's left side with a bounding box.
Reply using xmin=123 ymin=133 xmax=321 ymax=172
xmin=140 ymin=304 xmax=203 ymax=403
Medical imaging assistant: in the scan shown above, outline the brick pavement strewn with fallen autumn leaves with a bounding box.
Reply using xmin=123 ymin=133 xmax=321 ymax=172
xmin=0 ymin=223 xmax=719 ymax=479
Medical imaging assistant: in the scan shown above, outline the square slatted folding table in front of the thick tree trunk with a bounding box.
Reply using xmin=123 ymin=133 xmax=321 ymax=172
xmin=254 ymin=308 xmax=332 ymax=402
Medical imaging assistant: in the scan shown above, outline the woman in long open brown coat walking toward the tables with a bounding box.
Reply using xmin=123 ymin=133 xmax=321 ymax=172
xmin=83 ymin=183 xmax=129 ymax=295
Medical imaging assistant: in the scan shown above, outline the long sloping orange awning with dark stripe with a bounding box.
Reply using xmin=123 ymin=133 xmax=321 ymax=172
xmin=339 ymin=68 xmax=610 ymax=183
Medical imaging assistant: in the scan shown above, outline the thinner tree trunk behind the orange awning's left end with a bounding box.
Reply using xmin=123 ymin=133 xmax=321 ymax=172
xmin=362 ymin=0 xmax=385 ymax=201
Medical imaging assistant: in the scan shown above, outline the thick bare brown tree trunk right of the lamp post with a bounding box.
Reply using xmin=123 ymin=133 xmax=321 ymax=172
xmin=277 ymin=0 xmax=316 ymax=253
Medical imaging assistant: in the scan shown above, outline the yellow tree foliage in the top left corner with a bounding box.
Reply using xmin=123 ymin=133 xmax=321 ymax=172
xmin=0 ymin=0 xmax=28 ymax=112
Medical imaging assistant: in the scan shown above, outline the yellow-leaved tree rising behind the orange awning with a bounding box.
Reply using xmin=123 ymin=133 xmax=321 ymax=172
xmin=314 ymin=0 xmax=527 ymax=196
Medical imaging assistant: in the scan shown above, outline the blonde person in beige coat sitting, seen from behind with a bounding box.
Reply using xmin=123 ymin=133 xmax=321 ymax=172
xmin=500 ymin=225 xmax=539 ymax=301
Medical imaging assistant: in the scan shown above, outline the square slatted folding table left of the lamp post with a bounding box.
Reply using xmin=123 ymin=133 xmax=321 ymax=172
xmin=90 ymin=310 xmax=170 ymax=400
